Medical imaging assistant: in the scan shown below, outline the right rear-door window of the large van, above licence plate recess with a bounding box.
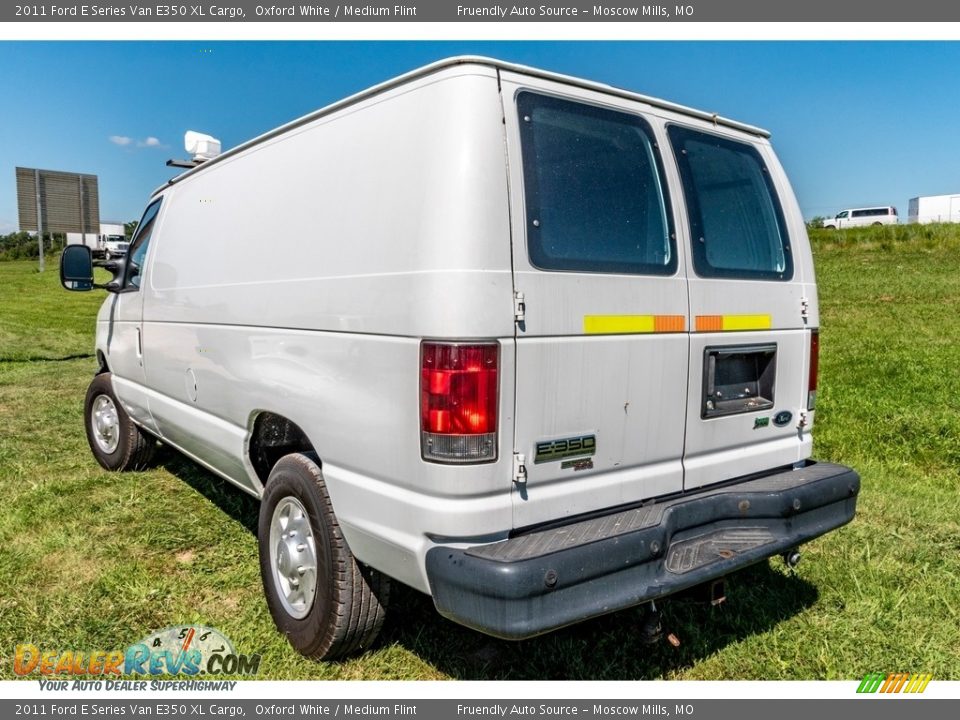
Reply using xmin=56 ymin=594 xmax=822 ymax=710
xmin=669 ymin=125 xmax=793 ymax=280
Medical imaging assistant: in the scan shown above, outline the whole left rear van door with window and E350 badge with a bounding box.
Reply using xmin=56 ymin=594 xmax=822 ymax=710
xmin=501 ymin=77 xmax=689 ymax=528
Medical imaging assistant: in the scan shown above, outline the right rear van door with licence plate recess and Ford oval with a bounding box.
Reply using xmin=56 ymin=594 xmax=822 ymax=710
xmin=667 ymin=124 xmax=815 ymax=489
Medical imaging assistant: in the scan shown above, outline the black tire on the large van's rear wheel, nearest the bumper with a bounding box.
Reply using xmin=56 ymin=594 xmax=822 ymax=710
xmin=258 ymin=453 xmax=390 ymax=660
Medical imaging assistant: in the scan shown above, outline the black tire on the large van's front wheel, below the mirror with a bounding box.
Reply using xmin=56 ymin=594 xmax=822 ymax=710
xmin=83 ymin=373 xmax=157 ymax=471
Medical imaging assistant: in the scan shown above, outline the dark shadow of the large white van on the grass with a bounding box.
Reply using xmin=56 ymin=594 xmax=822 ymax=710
xmin=157 ymin=448 xmax=817 ymax=680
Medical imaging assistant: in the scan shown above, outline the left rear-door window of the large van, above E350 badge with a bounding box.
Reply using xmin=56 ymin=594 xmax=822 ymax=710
xmin=517 ymin=92 xmax=677 ymax=275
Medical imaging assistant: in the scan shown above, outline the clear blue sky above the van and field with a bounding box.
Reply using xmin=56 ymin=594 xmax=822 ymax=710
xmin=0 ymin=41 xmax=960 ymax=233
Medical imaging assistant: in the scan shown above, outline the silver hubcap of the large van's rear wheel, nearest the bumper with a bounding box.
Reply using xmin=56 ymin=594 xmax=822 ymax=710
xmin=270 ymin=497 xmax=317 ymax=620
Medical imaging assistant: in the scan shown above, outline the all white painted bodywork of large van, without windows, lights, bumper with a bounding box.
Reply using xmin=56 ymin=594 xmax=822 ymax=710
xmin=97 ymin=60 xmax=836 ymax=592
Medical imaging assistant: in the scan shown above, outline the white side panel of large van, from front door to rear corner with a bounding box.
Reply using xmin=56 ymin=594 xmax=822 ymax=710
xmin=128 ymin=66 xmax=513 ymax=590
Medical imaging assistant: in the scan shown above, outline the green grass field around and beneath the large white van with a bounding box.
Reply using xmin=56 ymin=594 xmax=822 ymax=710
xmin=0 ymin=226 xmax=960 ymax=679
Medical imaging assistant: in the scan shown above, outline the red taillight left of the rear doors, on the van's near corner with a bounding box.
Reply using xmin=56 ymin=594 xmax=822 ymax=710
xmin=420 ymin=342 xmax=500 ymax=463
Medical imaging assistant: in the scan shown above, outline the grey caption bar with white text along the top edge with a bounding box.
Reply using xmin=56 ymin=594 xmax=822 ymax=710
xmin=7 ymin=0 xmax=960 ymax=23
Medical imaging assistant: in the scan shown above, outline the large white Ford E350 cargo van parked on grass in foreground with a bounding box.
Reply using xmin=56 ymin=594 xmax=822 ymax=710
xmin=61 ymin=58 xmax=860 ymax=658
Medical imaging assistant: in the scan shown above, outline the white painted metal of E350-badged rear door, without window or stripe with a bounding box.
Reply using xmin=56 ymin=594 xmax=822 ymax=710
xmin=501 ymin=71 xmax=689 ymax=527
